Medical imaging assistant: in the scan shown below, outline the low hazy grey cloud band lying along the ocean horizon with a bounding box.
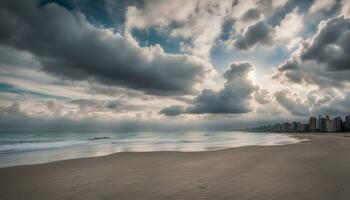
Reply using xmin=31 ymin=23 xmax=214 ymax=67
xmin=0 ymin=108 xmax=300 ymax=133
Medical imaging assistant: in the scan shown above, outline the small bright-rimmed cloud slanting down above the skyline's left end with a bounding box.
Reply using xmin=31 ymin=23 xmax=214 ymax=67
xmin=274 ymin=90 xmax=309 ymax=116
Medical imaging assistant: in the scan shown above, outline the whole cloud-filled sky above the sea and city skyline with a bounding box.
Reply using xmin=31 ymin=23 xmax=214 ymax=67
xmin=0 ymin=0 xmax=350 ymax=131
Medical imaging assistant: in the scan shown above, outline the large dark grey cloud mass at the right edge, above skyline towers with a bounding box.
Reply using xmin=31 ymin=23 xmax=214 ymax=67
xmin=274 ymin=17 xmax=350 ymax=89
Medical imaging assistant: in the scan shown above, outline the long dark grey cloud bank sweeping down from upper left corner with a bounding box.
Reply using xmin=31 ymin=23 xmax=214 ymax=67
xmin=0 ymin=0 xmax=205 ymax=95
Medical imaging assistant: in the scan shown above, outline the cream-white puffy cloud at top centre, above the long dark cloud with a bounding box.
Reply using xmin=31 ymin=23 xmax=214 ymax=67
xmin=126 ymin=0 xmax=233 ymax=59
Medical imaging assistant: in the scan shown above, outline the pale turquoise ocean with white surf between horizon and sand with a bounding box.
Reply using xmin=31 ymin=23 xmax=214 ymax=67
xmin=0 ymin=131 xmax=301 ymax=167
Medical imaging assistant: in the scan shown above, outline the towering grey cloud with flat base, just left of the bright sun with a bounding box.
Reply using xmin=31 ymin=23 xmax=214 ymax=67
xmin=161 ymin=62 xmax=257 ymax=115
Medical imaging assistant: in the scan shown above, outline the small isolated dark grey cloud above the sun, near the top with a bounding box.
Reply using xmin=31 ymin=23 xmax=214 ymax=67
xmin=234 ymin=21 xmax=273 ymax=50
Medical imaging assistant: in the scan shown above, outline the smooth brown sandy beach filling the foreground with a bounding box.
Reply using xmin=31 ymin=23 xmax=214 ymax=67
xmin=0 ymin=135 xmax=350 ymax=200
